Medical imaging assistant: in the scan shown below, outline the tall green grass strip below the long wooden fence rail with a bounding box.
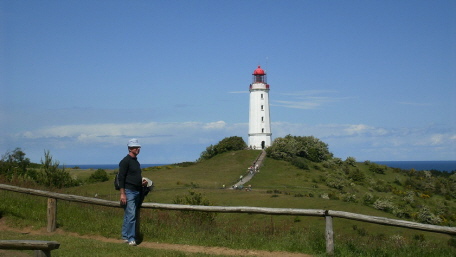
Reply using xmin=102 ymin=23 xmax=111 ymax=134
xmin=0 ymin=188 xmax=456 ymax=256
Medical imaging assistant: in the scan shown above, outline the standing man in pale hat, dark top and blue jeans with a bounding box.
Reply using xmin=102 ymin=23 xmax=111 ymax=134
xmin=118 ymin=138 xmax=147 ymax=246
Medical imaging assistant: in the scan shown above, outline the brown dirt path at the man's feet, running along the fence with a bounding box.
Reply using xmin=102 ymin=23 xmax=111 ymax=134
xmin=0 ymin=219 xmax=311 ymax=257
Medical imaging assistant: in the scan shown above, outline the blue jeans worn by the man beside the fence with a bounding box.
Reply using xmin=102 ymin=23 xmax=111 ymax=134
xmin=122 ymin=189 xmax=141 ymax=242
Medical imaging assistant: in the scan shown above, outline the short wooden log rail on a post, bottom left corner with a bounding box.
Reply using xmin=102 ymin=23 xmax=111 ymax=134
xmin=0 ymin=240 xmax=60 ymax=257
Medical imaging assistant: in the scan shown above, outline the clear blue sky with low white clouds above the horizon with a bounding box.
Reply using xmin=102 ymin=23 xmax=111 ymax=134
xmin=0 ymin=0 xmax=456 ymax=164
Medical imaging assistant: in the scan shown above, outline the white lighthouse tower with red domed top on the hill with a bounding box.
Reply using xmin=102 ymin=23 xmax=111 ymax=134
xmin=249 ymin=66 xmax=272 ymax=149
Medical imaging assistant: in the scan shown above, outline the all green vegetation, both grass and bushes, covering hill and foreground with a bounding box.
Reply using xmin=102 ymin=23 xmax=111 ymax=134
xmin=0 ymin=135 xmax=456 ymax=256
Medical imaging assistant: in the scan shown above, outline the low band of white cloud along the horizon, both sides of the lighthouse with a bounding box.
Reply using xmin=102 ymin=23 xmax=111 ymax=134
xmin=6 ymin=121 xmax=456 ymax=163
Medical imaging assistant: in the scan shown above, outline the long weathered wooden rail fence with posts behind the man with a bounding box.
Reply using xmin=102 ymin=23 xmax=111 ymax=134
xmin=0 ymin=184 xmax=456 ymax=254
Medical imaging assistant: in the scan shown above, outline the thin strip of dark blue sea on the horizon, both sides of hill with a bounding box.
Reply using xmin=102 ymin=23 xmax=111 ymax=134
xmin=65 ymin=161 xmax=456 ymax=172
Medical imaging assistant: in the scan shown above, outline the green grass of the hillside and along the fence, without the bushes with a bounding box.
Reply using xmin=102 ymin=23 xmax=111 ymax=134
xmin=0 ymin=151 xmax=456 ymax=257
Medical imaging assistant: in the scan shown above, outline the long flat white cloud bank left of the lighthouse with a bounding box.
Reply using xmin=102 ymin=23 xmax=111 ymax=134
xmin=16 ymin=121 xmax=242 ymax=145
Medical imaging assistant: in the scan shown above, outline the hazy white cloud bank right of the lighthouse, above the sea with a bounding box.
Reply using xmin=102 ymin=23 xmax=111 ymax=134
xmin=271 ymin=122 xmax=456 ymax=160
